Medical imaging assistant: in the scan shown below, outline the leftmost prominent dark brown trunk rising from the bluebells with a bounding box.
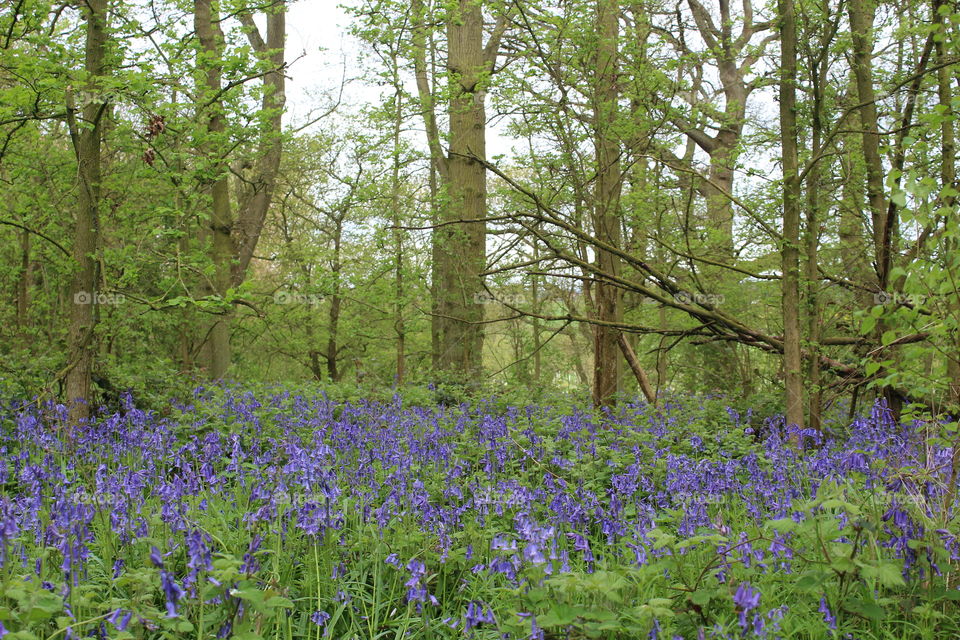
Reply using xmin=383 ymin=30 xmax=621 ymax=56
xmin=65 ymin=0 xmax=109 ymax=424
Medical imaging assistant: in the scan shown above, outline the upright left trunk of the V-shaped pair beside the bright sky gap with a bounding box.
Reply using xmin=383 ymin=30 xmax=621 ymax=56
xmin=193 ymin=0 xmax=237 ymax=380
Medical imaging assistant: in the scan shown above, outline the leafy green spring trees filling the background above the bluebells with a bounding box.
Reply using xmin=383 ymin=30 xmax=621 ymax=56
xmin=0 ymin=0 xmax=960 ymax=428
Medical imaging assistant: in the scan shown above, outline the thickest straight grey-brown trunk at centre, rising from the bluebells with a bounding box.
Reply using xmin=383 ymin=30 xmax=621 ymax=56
xmin=438 ymin=0 xmax=489 ymax=381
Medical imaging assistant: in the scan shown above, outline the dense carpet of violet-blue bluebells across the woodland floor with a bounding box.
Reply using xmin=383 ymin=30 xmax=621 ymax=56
xmin=0 ymin=390 xmax=960 ymax=637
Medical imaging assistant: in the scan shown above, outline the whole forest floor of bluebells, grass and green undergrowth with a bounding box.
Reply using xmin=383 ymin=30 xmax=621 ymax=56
xmin=0 ymin=388 xmax=960 ymax=639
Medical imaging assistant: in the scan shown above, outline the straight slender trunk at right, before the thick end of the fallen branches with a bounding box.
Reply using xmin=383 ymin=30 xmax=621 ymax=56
xmin=779 ymin=0 xmax=804 ymax=440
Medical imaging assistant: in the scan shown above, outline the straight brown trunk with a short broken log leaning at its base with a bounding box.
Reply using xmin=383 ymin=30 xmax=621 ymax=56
xmin=593 ymin=0 xmax=623 ymax=406
